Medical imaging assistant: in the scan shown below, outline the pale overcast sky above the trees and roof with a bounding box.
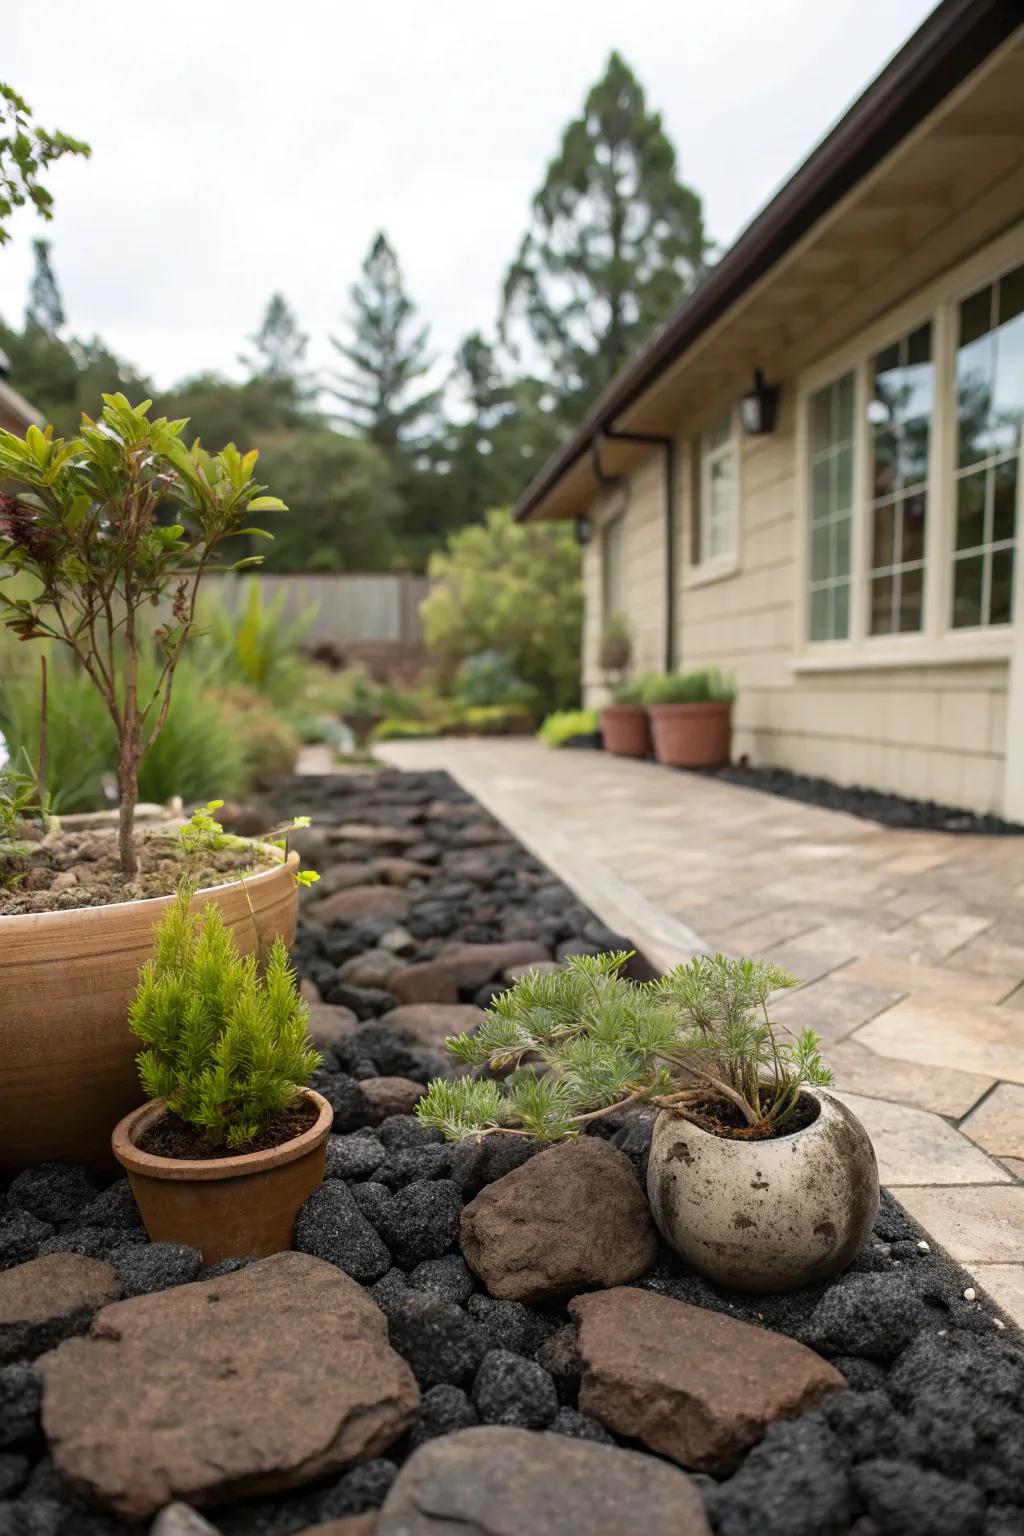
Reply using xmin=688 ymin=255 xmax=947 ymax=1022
xmin=0 ymin=0 xmax=932 ymax=386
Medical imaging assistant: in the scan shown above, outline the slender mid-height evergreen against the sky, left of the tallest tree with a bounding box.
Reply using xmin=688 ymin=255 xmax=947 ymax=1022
xmin=330 ymin=230 xmax=441 ymax=465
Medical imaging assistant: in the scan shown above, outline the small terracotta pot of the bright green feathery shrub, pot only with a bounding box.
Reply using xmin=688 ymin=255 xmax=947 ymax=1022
xmin=111 ymin=1087 xmax=335 ymax=1264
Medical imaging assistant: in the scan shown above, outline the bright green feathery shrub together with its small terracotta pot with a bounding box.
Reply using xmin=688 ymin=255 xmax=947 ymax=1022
xmin=112 ymin=885 xmax=333 ymax=1264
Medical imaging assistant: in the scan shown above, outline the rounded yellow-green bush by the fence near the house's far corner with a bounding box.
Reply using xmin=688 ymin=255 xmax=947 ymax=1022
xmin=419 ymin=511 xmax=583 ymax=711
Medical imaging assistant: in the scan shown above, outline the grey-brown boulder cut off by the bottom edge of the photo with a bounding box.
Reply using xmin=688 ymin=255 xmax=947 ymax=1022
xmin=376 ymin=1425 xmax=711 ymax=1536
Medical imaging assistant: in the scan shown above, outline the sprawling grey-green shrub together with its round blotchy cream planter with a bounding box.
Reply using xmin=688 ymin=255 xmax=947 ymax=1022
xmin=416 ymin=954 xmax=878 ymax=1290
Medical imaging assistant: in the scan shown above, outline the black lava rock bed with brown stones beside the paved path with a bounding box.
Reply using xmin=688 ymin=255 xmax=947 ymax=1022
xmin=0 ymin=773 xmax=1024 ymax=1536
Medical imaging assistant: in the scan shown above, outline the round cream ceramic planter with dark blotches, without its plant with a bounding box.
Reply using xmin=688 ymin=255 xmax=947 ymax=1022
xmin=648 ymin=1091 xmax=878 ymax=1290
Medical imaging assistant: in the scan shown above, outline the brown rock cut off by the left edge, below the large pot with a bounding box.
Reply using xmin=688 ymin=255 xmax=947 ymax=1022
xmin=0 ymin=1253 xmax=121 ymax=1364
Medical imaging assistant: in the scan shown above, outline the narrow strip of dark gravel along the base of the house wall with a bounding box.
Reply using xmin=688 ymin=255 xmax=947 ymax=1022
xmin=689 ymin=762 xmax=1024 ymax=836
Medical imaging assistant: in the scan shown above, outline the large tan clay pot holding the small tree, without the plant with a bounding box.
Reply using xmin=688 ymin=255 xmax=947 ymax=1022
xmin=0 ymin=852 xmax=299 ymax=1170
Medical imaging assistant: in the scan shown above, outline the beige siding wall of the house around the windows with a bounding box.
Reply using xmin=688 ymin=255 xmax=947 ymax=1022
xmin=583 ymin=233 xmax=1024 ymax=813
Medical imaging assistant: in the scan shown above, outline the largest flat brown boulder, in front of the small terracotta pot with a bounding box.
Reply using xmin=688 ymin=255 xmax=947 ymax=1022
xmin=37 ymin=1253 xmax=419 ymax=1521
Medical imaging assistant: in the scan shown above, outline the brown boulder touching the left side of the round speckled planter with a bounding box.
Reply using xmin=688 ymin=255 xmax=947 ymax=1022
xmin=459 ymin=1137 xmax=657 ymax=1303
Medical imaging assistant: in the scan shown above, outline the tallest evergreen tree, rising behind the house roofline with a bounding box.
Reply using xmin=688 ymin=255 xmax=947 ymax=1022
xmin=502 ymin=52 xmax=709 ymax=419
